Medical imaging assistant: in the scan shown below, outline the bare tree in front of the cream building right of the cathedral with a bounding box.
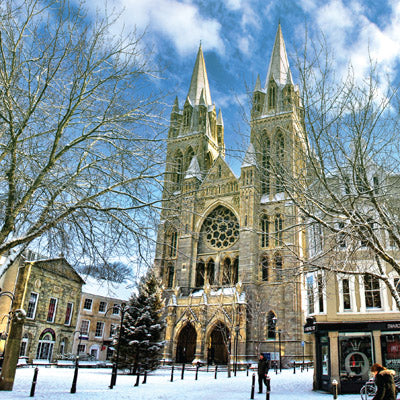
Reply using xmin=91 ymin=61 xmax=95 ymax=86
xmin=271 ymin=32 xmax=400 ymax=306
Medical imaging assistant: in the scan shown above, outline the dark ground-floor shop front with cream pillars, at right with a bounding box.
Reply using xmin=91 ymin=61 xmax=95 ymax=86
xmin=304 ymin=320 xmax=400 ymax=393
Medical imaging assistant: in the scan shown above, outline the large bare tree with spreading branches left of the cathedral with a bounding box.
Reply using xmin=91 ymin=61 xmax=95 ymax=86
xmin=0 ymin=0 xmax=164 ymax=272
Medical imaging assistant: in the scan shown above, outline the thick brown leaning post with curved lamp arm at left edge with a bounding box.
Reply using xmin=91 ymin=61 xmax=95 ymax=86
xmin=0 ymin=288 xmax=26 ymax=390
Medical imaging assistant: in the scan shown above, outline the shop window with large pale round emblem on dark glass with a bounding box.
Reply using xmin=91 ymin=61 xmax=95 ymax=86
xmin=339 ymin=333 xmax=373 ymax=383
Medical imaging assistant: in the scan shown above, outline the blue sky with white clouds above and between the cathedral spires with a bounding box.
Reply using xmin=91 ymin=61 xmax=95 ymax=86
xmin=83 ymin=0 xmax=400 ymax=173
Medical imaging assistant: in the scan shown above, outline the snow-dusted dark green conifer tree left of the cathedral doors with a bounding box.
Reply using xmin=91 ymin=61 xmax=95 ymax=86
xmin=118 ymin=271 xmax=164 ymax=373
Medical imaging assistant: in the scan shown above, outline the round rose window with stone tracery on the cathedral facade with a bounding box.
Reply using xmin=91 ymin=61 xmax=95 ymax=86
xmin=202 ymin=206 xmax=239 ymax=249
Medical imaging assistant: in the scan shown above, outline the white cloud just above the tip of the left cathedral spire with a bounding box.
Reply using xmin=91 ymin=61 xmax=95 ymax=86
xmin=87 ymin=0 xmax=225 ymax=54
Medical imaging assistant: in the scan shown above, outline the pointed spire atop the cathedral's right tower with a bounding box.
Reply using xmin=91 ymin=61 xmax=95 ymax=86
xmin=265 ymin=23 xmax=293 ymax=87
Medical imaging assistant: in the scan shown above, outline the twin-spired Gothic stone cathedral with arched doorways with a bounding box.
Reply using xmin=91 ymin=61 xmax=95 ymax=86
xmin=155 ymin=25 xmax=312 ymax=365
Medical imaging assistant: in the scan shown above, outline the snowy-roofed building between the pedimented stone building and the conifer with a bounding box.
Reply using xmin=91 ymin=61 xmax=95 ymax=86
xmin=73 ymin=276 xmax=132 ymax=361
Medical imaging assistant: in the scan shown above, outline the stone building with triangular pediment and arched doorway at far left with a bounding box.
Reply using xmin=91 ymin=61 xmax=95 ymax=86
xmin=0 ymin=257 xmax=84 ymax=363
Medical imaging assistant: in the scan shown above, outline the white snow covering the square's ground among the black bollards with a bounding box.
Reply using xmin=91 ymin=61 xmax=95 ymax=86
xmin=5 ymin=367 xmax=361 ymax=400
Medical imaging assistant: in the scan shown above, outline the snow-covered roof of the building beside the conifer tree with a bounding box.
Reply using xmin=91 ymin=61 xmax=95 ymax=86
xmin=82 ymin=276 xmax=134 ymax=300
